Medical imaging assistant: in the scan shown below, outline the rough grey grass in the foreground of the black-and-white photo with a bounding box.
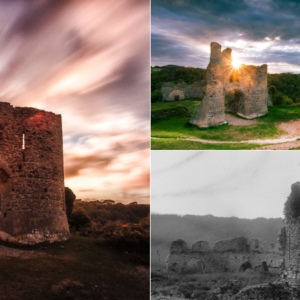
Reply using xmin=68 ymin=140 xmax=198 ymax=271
xmin=151 ymin=271 xmax=279 ymax=300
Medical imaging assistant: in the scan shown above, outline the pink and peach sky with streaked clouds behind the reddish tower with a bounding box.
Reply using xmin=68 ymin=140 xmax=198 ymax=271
xmin=0 ymin=0 xmax=150 ymax=203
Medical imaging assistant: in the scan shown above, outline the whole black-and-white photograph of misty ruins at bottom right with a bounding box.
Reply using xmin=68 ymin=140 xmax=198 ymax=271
xmin=151 ymin=151 xmax=300 ymax=300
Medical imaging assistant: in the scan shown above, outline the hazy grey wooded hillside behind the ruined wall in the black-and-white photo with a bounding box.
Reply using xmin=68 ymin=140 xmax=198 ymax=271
xmin=151 ymin=214 xmax=282 ymax=269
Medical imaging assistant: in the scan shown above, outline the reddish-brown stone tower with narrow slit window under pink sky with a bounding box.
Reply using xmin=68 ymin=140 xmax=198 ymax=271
xmin=0 ymin=102 xmax=69 ymax=244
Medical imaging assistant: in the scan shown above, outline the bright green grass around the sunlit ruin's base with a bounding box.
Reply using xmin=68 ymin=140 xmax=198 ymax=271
xmin=151 ymin=99 xmax=300 ymax=149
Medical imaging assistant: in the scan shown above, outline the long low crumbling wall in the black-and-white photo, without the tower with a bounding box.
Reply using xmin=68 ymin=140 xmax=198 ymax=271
xmin=167 ymin=237 xmax=283 ymax=274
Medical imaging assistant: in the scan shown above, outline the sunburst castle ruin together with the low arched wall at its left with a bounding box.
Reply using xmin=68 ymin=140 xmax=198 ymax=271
xmin=161 ymin=42 xmax=268 ymax=127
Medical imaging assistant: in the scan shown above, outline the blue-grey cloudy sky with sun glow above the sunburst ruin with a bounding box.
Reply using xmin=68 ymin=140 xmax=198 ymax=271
xmin=151 ymin=0 xmax=300 ymax=73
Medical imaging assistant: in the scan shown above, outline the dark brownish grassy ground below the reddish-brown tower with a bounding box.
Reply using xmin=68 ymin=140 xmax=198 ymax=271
xmin=0 ymin=237 xmax=149 ymax=300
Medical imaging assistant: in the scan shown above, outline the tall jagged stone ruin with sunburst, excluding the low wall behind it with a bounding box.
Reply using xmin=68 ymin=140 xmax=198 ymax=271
xmin=190 ymin=42 xmax=268 ymax=127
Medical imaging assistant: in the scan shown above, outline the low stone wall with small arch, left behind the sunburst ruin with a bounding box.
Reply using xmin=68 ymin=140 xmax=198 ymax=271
xmin=161 ymin=80 xmax=205 ymax=101
